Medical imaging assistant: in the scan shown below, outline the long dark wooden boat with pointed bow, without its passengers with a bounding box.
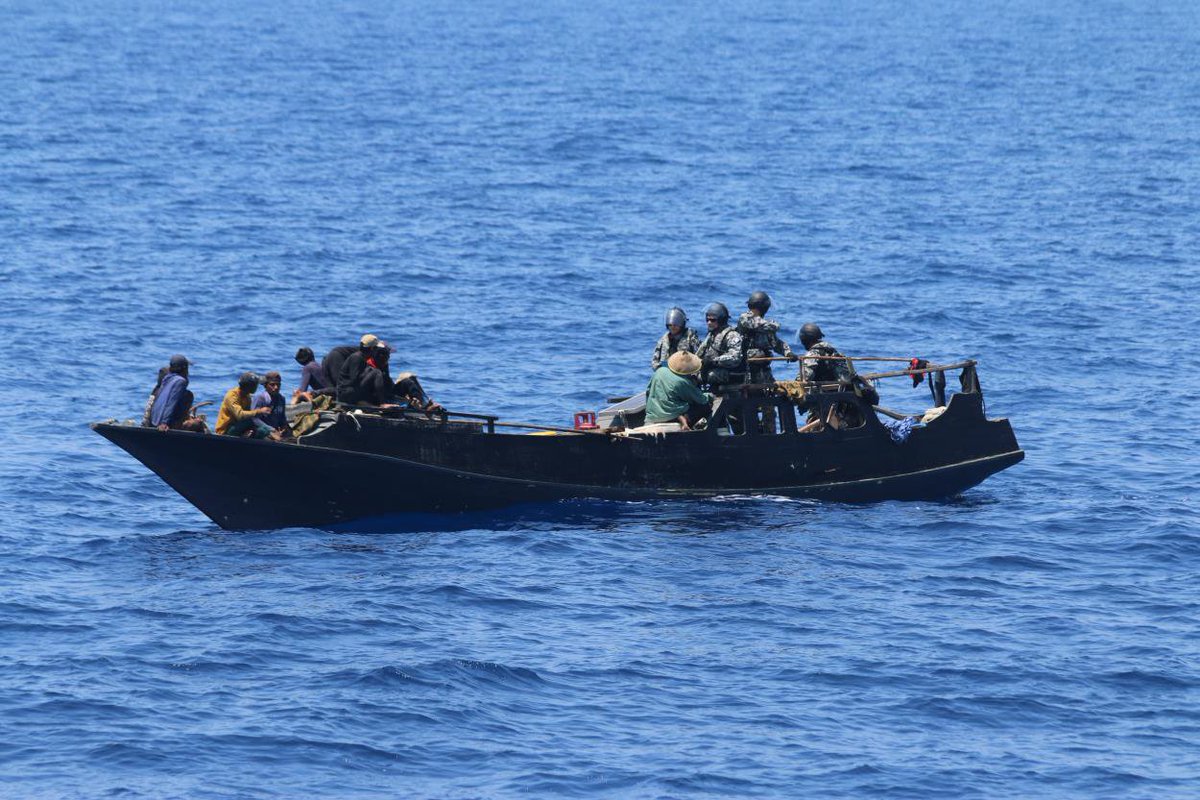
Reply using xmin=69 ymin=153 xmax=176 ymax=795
xmin=92 ymin=361 xmax=1025 ymax=529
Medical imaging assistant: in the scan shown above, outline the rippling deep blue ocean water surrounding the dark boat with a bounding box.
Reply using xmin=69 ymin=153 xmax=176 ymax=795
xmin=0 ymin=0 xmax=1200 ymax=799
